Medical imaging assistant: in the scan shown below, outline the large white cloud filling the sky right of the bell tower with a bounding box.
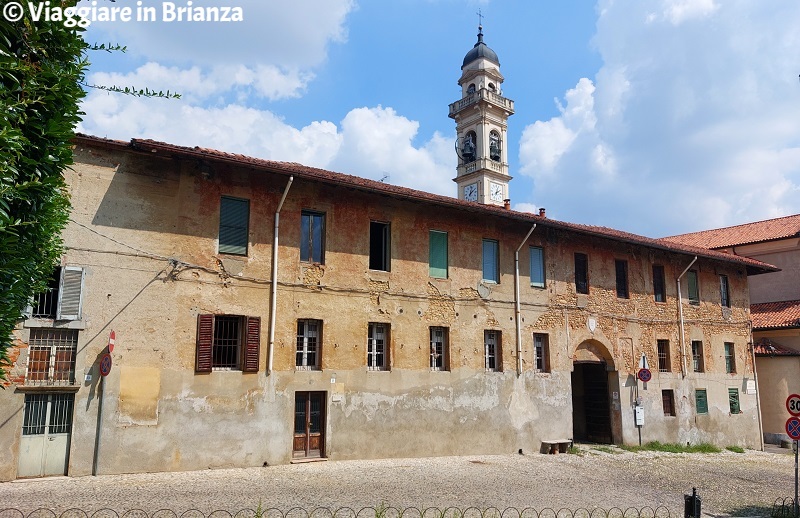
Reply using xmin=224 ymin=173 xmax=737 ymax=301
xmin=520 ymin=0 xmax=800 ymax=235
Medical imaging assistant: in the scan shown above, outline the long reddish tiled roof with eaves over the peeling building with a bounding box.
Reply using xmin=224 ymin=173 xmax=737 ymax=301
xmin=75 ymin=134 xmax=778 ymax=275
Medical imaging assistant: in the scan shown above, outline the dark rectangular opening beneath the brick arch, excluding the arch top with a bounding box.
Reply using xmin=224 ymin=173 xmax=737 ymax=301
xmin=572 ymin=362 xmax=612 ymax=444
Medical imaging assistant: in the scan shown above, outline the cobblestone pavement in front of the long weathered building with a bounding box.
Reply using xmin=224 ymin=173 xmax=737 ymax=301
xmin=0 ymin=445 xmax=794 ymax=518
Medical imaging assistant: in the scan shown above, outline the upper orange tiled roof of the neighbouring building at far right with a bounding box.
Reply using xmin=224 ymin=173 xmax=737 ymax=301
xmin=663 ymin=214 xmax=800 ymax=249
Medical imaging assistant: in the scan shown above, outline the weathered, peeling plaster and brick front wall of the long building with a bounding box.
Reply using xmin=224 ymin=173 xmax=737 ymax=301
xmin=0 ymin=146 xmax=759 ymax=480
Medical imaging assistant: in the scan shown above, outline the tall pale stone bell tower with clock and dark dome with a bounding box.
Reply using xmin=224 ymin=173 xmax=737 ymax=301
xmin=449 ymin=25 xmax=514 ymax=206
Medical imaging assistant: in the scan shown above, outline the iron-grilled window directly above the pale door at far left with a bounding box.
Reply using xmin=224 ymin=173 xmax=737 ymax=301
xmin=25 ymin=328 xmax=78 ymax=385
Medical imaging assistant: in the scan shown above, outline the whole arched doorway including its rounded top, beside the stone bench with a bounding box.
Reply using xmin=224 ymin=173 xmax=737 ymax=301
xmin=572 ymin=340 xmax=619 ymax=444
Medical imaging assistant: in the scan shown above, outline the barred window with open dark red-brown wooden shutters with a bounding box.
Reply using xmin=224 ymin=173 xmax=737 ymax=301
xmin=194 ymin=315 xmax=261 ymax=372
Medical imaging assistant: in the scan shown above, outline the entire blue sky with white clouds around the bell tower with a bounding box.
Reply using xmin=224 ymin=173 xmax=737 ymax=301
xmin=79 ymin=0 xmax=800 ymax=237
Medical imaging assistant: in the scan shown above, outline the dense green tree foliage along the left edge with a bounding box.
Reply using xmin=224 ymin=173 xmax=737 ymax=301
xmin=0 ymin=0 xmax=89 ymax=377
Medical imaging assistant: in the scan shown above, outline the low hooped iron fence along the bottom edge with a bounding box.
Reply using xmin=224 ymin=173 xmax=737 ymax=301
xmin=0 ymin=506 xmax=676 ymax=518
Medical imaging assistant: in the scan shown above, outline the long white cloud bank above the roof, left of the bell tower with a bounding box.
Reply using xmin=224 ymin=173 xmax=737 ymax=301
xmin=78 ymin=92 xmax=456 ymax=196
